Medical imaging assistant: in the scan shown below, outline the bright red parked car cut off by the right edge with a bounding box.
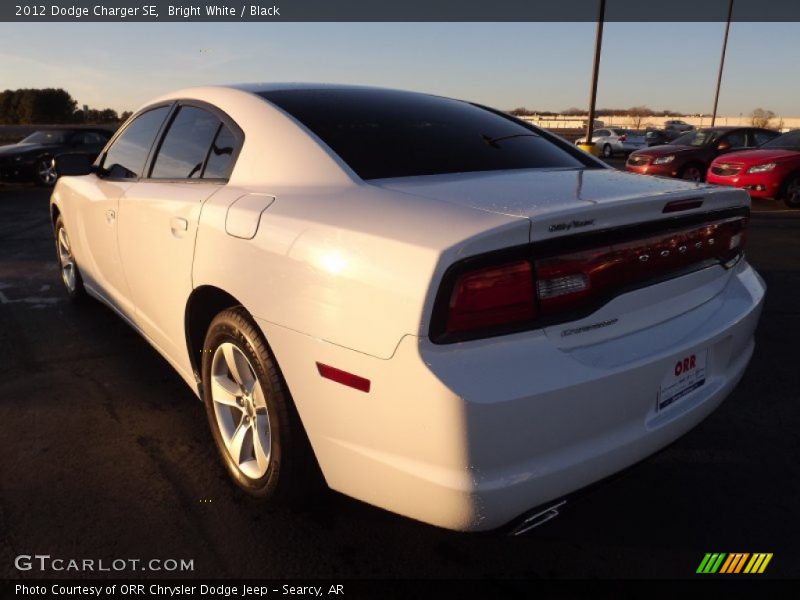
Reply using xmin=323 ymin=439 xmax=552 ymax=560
xmin=706 ymin=129 xmax=800 ymax=208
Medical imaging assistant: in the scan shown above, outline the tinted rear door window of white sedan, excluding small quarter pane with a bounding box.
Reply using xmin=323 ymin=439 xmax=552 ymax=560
xmin=150 ymin=106 xmax=220 ymax=179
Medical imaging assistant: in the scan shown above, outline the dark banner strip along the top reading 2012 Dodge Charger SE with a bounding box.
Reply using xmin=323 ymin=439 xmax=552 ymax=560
xmin=0 ymin=0 xmax=800 ymax=23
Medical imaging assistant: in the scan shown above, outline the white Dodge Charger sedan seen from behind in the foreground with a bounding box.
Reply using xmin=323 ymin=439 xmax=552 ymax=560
xmin=51 ymin=84 xmax=764 ymax=530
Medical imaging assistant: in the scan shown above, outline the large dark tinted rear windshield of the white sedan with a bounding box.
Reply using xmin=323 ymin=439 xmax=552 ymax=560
xmin=260 ymin=89 xmax=594 ymax=179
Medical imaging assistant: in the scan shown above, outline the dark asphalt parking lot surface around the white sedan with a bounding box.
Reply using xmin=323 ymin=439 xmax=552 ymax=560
xmin=0 ymin=186 xmax=800 ymax=579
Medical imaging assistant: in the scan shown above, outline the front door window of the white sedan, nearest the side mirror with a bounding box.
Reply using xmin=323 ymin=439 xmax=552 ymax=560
xmin=101 ymin=106 xmax=169 ymax=179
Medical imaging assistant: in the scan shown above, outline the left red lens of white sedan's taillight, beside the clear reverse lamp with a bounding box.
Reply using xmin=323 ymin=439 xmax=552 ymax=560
xmin=446 ymin=260 xmax=534 ymax=333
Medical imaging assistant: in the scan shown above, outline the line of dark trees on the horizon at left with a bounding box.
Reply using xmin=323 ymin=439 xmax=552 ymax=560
xmin=0 ymin=88 xmax=131 ymax=125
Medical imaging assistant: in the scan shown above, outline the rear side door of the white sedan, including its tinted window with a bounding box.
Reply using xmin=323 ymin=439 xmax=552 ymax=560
xmin=119 ymin=103 xmax=242 ymax=372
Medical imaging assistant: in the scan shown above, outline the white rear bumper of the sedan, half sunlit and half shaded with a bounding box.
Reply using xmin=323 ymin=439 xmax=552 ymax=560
xmin=259 ymin=261 xmax=764 ymax=531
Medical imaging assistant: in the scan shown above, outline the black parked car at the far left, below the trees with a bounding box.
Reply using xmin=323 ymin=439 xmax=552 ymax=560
xmin=0 ymin=129 xmax=112 ymax=187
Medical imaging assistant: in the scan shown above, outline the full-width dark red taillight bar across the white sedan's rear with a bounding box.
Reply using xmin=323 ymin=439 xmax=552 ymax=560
xmin=431 ymin=217 xmax=747 ymax=342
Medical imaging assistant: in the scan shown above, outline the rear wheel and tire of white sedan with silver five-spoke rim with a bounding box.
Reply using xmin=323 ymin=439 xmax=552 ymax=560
xmin=201 ymin=306 xmax=321 ymax=501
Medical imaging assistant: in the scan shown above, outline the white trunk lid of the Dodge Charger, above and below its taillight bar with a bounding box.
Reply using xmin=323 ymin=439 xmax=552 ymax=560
xmin=371 ymin=169 xmax=750 ymax=356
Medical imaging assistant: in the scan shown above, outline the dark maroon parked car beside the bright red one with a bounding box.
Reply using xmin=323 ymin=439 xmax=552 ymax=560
xmin=625 ymin=127 xmax=780 ymax=181
